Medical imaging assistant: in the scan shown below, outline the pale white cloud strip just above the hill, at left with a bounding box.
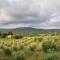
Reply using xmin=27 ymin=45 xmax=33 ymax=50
xmin=0 ymin=24 xmax=30 ymax=29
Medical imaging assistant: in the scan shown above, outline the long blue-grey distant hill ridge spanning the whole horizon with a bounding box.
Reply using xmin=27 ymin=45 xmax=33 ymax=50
xmin=0 ymin=27 xmax=60 ymax=33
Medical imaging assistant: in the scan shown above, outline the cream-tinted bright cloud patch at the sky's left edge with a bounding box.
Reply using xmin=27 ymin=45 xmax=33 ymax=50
xmin=0 ymin=9 xmax=11 ymax=24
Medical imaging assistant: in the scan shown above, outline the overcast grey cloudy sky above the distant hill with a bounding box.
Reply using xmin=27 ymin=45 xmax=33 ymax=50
xmin=0 ymin=0 xmax=60 ymax=29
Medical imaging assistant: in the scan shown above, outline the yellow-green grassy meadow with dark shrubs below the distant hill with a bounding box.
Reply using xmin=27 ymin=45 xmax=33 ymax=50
xmin=0 ymin=33 xmax=60 ymax=60
